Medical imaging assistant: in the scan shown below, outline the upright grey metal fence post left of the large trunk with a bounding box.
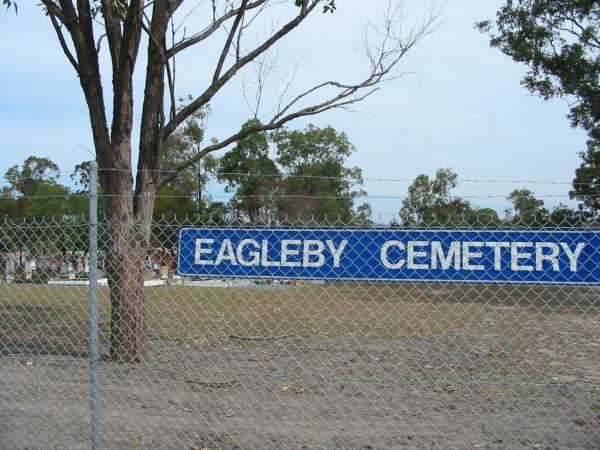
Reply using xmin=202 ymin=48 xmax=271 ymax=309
xmin=89 ymin=161 xmax=100 ymax=450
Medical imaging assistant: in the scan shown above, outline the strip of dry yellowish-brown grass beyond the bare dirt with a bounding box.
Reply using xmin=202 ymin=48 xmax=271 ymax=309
xmin=0 ymin=283 xmax=600 ymax=377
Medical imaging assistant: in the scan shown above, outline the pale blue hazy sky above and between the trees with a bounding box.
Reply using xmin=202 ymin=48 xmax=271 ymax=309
xmin=0 ymin=0 xmax=586 ymax=222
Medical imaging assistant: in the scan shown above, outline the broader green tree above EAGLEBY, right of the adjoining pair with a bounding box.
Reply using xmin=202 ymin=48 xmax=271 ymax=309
xmin=272 ymin=125 xmax=367 ymax=224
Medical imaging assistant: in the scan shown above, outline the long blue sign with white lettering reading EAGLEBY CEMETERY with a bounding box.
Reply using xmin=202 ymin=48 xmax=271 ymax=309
xmin=178 ymin=228 xmax=600 ymax=284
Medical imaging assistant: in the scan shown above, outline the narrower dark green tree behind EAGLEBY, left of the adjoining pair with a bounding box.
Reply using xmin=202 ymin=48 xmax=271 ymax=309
xmin=218 ymin=119 xmax=280 ymax=222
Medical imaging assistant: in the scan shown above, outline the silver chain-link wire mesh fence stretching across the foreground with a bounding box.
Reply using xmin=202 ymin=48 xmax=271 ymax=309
xmin=0 ymin=199 xmax=600 ymax=448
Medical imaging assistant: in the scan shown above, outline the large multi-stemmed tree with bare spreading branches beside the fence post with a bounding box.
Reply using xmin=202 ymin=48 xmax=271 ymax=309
xmin=3 ymin=0 xmax=438 ymax=362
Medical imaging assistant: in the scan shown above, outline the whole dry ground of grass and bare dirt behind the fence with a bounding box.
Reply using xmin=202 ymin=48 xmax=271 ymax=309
xmin=0 ymin=282 xmax=600 ymax=448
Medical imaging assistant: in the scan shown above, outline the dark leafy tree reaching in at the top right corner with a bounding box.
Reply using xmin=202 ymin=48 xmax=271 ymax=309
xmin=477 ymin=0 xmax=600 ymax=211
